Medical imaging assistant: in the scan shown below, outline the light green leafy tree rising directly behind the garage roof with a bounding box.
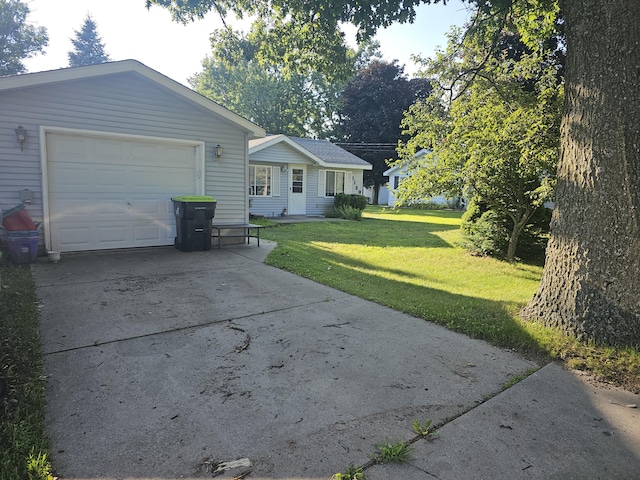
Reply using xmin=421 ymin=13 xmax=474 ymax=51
xmin=189 ymin=23 xmax=355 ymax=137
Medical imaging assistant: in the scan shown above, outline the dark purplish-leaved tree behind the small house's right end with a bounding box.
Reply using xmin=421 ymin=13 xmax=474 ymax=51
xmin=336 ymin=61 xmax=431 ymax=202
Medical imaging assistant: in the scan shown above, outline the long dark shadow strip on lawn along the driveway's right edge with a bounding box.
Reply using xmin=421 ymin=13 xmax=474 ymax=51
xmin=267 ymin=243 xmax=543 ymax=354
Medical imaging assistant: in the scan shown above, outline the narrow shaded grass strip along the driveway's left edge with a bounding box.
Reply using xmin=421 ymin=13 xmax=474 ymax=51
xmin=0 ymin=268 xmax=53 ymax=480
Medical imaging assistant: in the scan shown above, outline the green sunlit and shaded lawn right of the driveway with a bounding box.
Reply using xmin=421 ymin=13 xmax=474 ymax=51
xmin=262 ymin=207 xmax=640 ymax=391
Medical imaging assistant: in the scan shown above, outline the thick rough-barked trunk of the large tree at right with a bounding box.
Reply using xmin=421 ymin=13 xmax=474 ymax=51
xmin=523 ymin=0 xmax=640 ymax=347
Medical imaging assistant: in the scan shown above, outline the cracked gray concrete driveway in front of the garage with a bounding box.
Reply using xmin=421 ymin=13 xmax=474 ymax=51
xmin=33 ymin=241 xmax=640 ymax=480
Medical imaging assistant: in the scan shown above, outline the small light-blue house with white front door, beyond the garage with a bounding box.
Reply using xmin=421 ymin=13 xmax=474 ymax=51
xmin=249 ymin=135 xmax=373 ymax=217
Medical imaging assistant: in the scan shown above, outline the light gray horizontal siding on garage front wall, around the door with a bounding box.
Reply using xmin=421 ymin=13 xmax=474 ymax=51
xmin=0 ymin=73 xmax=248 ymax=236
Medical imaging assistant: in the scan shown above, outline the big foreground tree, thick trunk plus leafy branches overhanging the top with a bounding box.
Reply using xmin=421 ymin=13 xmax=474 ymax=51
xmin=146 ymin=0 xmax=640 ymax=347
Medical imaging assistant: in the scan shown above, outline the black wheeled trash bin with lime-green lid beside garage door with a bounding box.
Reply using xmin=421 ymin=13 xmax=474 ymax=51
xmin=171 ymin=195 xmax=217 ymax=252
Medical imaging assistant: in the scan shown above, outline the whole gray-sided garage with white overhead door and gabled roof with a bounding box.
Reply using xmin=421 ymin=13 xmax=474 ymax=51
xmin=0 ymin=60 xmax=265 ymax=252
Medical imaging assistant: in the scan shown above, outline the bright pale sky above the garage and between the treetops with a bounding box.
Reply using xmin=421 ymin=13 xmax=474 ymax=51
xmin=25 ymin=0 xmax=468 ymax=85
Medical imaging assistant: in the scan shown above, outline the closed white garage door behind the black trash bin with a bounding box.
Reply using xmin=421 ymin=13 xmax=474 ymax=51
xmin=47 ymin=133 xmax=201 ymax=252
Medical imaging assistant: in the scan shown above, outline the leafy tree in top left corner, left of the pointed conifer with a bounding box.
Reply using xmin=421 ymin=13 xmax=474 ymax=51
xmin=0 ymin=0 xmax=49 ymax=76
